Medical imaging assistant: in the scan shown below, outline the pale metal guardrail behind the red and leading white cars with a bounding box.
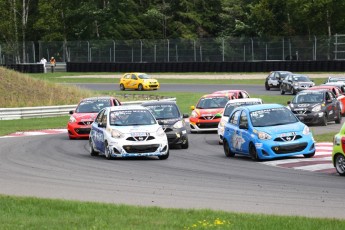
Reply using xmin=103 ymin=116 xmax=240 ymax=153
xmin=0 ymin=98 xmax=176 ymax=120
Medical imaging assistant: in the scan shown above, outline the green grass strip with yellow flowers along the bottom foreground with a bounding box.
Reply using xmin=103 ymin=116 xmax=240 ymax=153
xmin=0 ymin=195 xmax=345 ymax=230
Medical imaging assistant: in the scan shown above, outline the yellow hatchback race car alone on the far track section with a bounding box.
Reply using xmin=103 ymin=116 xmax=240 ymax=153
xmin=120 ymin=73 xmax=159 ymax=91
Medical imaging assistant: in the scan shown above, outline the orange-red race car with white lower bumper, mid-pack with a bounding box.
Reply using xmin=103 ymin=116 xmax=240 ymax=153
xmin=189 ymin=93 xmax=234 ymax=133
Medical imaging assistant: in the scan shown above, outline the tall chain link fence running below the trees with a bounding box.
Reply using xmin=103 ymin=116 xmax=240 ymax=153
xmin=0 ymin=35 xmax=345 ymax=64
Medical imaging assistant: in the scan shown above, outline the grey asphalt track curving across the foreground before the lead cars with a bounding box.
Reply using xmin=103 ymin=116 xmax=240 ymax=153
xmin=0 ymin=82 xmax=345 ymax=218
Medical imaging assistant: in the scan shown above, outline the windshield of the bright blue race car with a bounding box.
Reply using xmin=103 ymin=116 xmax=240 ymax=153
xmin=250 ymin=107 xmax=298 ymax=127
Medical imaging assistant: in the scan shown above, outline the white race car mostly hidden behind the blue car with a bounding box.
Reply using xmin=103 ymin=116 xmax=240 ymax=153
xmin=217 ymin=98 xmax=263 ymax=144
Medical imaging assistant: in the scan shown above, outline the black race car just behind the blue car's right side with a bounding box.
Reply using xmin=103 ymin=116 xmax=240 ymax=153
xmin=288 ymin=89 xmax=342 ymax=126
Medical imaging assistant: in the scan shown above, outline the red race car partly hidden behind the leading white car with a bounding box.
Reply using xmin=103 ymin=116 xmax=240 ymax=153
xmin=67 ymin=96 xmax=121 ymax=139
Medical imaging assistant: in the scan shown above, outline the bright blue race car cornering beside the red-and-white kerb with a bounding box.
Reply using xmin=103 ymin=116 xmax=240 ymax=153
xmin=223 ymin=104 xmax=315 ymax=160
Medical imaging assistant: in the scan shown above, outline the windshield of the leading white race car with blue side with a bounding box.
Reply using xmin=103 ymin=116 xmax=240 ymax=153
xmin=109 ymin=109 xmax=156 ymax=126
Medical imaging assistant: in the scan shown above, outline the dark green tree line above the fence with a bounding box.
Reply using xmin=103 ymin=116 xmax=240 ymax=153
xmin=0 ymin=0 xmax=345 ymax=45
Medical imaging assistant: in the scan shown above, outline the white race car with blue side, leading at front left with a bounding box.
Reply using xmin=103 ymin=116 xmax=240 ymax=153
xmin=89 ymin=105 xmax=169 ymax=160
